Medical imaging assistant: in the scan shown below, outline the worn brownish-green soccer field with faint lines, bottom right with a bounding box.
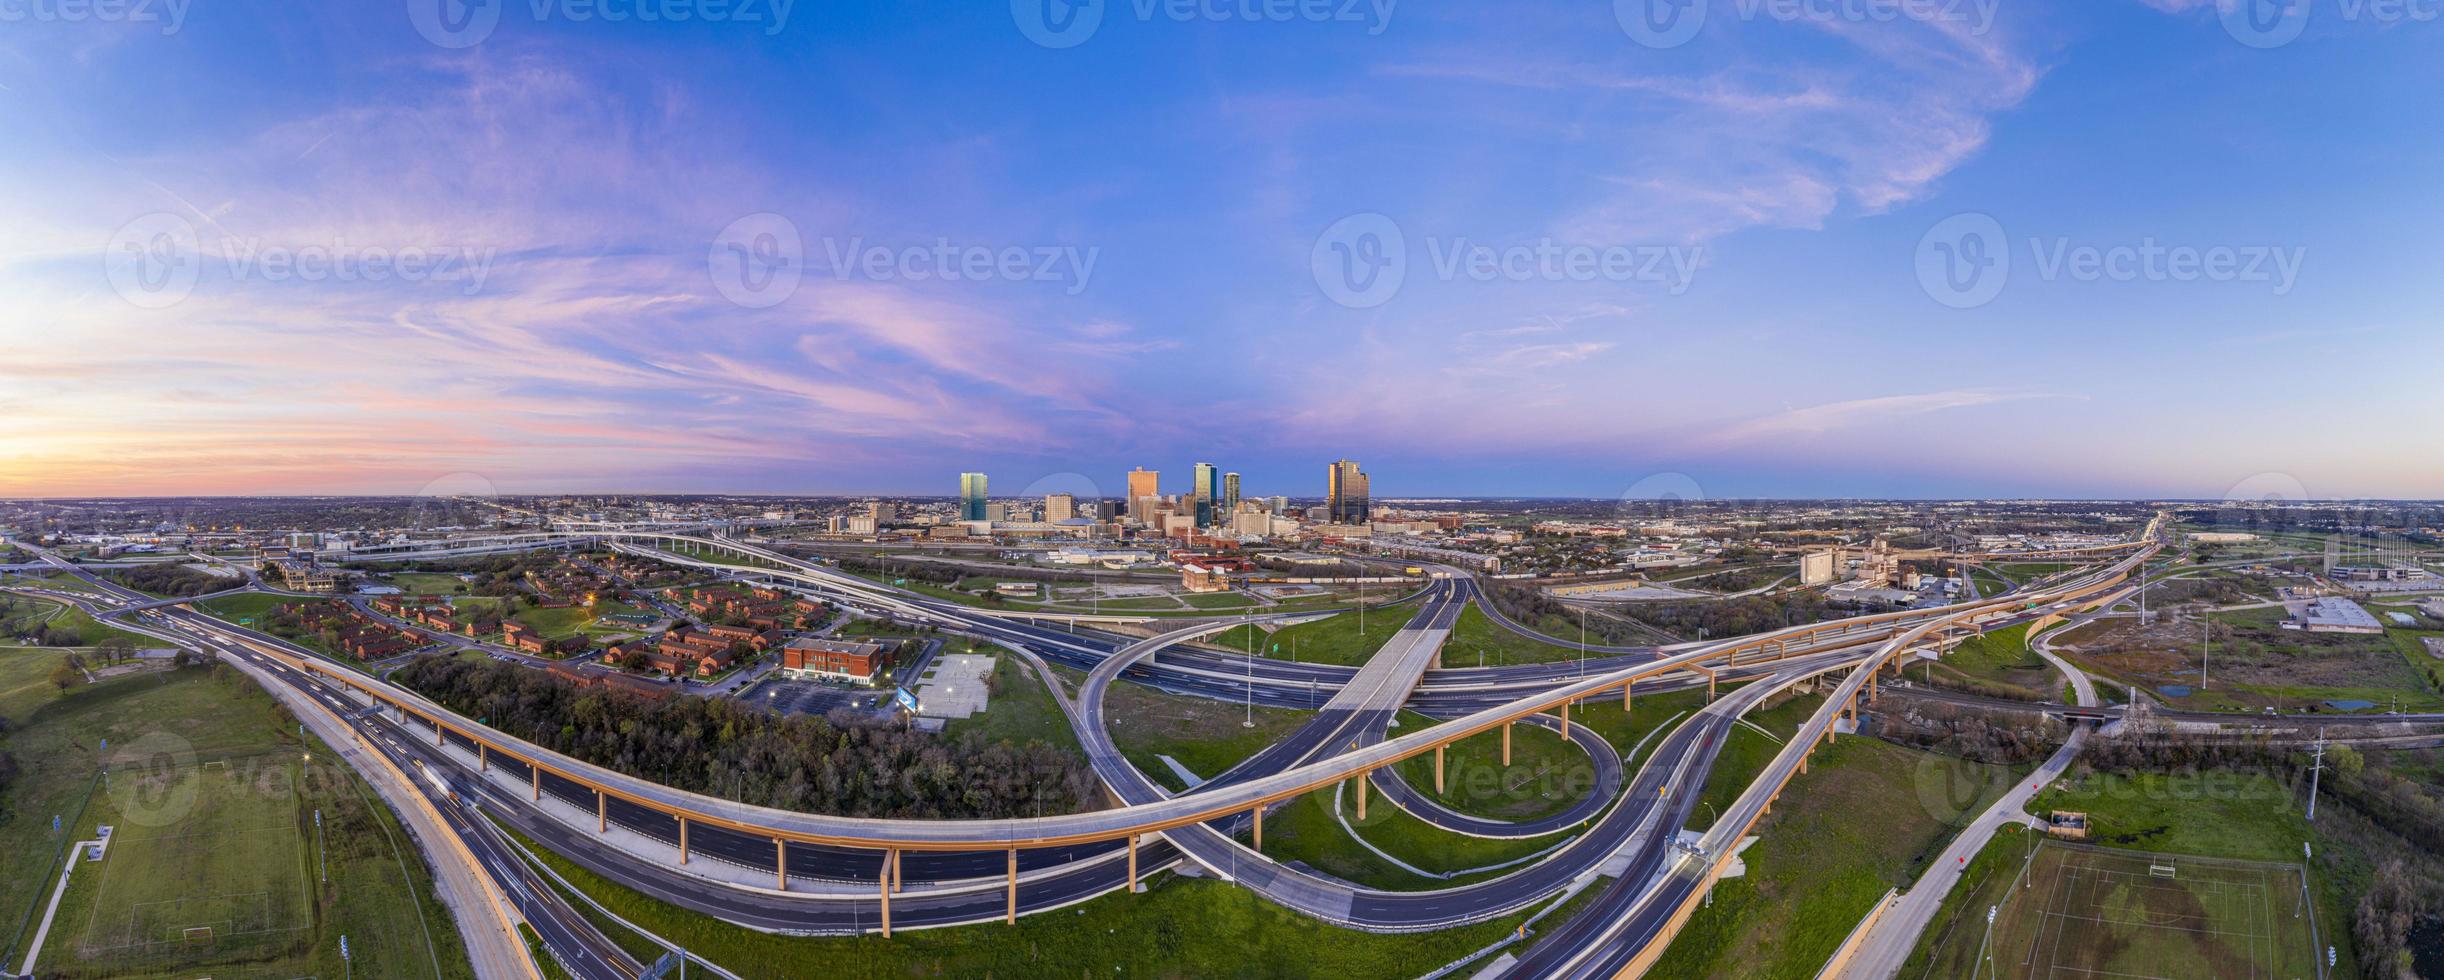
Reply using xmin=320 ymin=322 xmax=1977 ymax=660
xmin=1980 ymin=841 xmax=2322 ymax=980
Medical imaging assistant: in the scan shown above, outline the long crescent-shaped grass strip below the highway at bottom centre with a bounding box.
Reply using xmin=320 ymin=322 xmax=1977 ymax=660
xmin=501 ymin=824 xmax=1584 ymax=978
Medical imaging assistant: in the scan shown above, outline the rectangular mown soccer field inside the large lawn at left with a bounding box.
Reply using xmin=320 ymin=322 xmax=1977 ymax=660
xmin=76 ymin=758 xmax=313 ymax=968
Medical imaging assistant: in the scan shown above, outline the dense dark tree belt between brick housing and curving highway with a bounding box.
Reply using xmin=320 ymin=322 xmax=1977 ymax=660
xmin=391 ymin=657 xmax=1102 ymax=819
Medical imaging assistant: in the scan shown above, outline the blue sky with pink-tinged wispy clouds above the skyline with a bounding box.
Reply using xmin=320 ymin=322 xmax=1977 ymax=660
xmin=0 ymin=0 xmax=2444 ymax=499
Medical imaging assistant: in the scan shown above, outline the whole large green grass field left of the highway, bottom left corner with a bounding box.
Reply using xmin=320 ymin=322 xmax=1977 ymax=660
xmin=0 ymin=650 xmax=472 ymax=978
